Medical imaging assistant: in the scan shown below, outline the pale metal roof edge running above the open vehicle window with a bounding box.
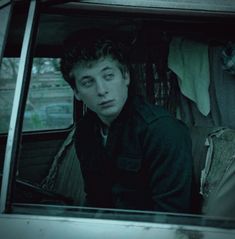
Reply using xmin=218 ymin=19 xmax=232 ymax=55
xmin=42 ymin=0 xmax=235 ymax=15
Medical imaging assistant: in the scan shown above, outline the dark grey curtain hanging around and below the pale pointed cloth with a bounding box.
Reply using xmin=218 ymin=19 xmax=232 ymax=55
xmin=179 ymin=45 xmax=235 ymax=129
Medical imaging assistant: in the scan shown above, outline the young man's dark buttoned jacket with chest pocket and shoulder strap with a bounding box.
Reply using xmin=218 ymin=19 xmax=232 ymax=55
xmin=74 ymin=98 xmax=192 ymax=212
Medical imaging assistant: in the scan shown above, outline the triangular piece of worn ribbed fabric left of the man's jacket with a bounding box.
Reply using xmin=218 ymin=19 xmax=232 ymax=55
xmin=41 ymin=129 xmax=85 ymax=206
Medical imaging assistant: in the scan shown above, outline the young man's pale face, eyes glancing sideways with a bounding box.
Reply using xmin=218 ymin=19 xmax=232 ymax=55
xmin=73 ymin=57 xmax=130 ymax=125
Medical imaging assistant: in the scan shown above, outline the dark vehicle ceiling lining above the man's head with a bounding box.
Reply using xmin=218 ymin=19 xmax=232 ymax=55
xmin=5 ymin=2 xmax=235 ymax=57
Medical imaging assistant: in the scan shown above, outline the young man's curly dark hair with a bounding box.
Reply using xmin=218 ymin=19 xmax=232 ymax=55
xmin=60 ymin=29 xmax=129 ymax=88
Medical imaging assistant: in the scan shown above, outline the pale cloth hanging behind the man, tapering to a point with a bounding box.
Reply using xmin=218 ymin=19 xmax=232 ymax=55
xmin=168 ymin=37 xmax=210 ymax=116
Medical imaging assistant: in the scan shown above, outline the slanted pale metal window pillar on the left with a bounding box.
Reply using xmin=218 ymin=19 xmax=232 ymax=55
xmin=0 ymin=1 xmax=39 ymax=213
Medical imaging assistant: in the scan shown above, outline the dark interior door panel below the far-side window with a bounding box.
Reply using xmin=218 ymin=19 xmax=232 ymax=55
xmin=0 ymin=130 xmax=73 ymax=203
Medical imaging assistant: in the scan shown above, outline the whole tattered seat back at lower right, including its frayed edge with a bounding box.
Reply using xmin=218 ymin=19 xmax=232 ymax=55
xmin=191 ymin=127 xmax=235 ymax=218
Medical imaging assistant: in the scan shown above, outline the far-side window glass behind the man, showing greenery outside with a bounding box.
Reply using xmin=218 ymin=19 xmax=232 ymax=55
xmin=0 ymin=58 xmax=73 ymax=133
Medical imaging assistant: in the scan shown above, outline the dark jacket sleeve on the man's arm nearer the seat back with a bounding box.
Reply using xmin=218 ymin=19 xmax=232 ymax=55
xmin=143 ymin=117 xmax=193 ymax=213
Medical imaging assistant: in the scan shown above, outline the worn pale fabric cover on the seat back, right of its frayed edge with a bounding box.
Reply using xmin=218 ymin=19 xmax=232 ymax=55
xmin=201 ymin=128 xmax=235 ymax=218
